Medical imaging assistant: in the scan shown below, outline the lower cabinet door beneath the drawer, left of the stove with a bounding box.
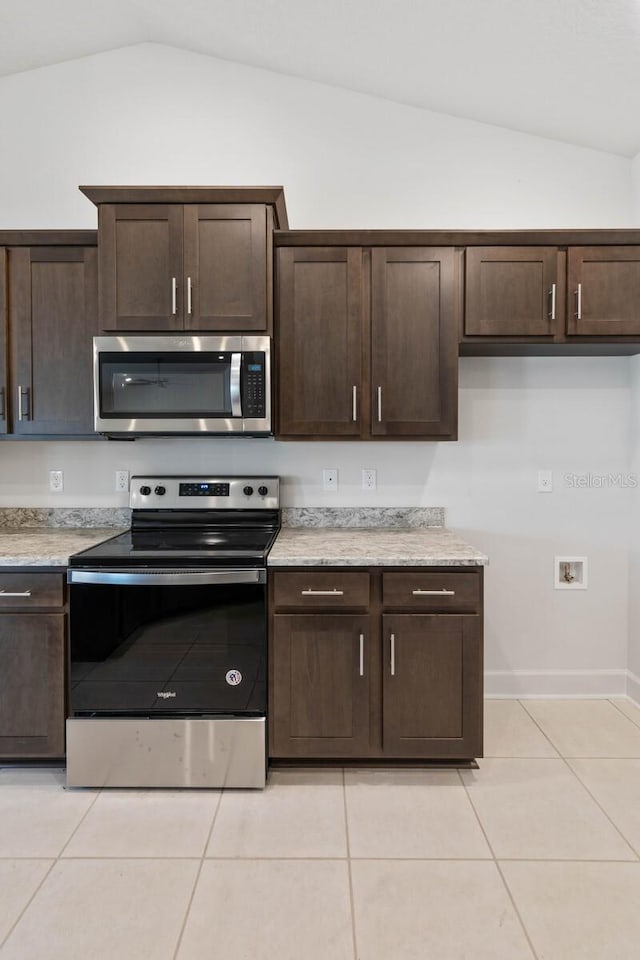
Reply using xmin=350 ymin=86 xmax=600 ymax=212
xmin=0 ymin=613 xmax=65 ymax=758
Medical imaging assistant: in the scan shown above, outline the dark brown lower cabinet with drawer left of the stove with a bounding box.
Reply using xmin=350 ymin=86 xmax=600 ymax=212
xmin=0 ymin=573 xmax=66 ymax=759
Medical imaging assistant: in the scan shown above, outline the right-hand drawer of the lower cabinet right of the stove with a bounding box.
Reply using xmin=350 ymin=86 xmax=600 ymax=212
xmin=382 ymin=570 xmax=480 ymax=612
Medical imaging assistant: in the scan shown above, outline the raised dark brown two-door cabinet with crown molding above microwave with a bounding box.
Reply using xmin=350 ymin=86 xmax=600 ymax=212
xmin=80 ymin=187 xmax=286 ymax=333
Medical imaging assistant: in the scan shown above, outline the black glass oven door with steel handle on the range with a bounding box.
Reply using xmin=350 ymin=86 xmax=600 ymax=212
xmin=67 ymin=568 xmax=267 ymax=717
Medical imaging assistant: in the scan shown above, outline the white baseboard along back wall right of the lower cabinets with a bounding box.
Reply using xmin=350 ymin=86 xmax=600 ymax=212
xmin=484 ymin=670 xmax=628 ymax=702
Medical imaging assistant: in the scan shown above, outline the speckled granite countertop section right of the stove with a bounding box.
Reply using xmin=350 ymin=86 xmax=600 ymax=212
xmin=268 ymin=527 xmax=489 ymax=567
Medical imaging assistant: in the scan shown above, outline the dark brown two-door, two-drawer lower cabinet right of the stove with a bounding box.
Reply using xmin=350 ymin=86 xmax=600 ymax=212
xmin=269 ymin=567 xmax=483 ymax=760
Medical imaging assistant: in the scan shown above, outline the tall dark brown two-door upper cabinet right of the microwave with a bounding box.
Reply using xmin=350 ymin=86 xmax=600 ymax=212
xmin=277 ymin=245 xmax=457 ymax=440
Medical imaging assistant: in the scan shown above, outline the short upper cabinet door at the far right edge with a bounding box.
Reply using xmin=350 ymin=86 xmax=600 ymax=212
xmin=567 ymin=246 xmax=640 ymax=337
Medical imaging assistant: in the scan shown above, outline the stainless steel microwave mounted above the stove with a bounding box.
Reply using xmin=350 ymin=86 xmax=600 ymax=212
xmin=93 ymin=335 xmax=272 ymax=437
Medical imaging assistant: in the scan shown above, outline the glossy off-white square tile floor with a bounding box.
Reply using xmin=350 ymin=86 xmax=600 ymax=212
xmin=0 ymin=700 xmax=640 ymax=960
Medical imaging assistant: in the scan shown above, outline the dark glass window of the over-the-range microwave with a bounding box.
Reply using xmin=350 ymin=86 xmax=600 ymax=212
xmin=99 ymin=352 xmax=232 ymax=419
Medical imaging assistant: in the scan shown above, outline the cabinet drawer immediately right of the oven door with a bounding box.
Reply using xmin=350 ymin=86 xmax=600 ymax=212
xmin=273 ymin=570 xmax=369 ymax=609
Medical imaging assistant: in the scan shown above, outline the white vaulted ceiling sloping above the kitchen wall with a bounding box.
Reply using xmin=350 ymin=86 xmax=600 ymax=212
xmin=0 ymin=0 xmax=640 ymax=157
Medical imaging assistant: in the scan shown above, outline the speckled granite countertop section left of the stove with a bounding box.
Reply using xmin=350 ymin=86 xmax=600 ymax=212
xmin=0 ymin=527 xmax=122 ymax=567
